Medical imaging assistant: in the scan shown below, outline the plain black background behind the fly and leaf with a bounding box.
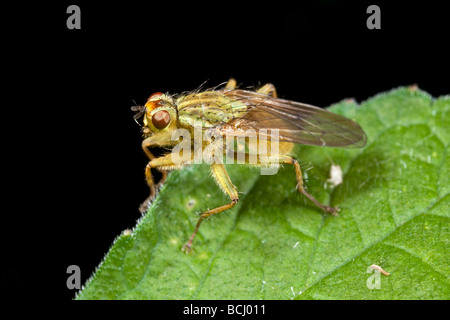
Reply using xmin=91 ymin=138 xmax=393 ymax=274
xmin=3 ymin=0 xmax=450 ymax=300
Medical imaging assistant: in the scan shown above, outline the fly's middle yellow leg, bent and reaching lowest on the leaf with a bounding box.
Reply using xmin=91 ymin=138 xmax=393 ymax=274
xmin=182 ymin=163 xmax=239 ymax=253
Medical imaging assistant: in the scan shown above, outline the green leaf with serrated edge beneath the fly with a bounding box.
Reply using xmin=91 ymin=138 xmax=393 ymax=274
xmin=77 ymin=87 xmax=450 ymax=299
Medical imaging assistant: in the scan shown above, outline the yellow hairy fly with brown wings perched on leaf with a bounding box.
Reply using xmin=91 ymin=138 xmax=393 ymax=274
xmin=132 ymin=79 xmax=367 ymax=252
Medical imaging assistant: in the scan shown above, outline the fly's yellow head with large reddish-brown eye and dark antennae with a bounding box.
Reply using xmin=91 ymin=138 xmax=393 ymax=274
xmin=132 ymin=92 xmax=177 ymax=145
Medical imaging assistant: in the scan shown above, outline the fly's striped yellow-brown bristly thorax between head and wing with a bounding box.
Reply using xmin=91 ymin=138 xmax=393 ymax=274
xmin=175 ymin=91 xmax=248 ymax=128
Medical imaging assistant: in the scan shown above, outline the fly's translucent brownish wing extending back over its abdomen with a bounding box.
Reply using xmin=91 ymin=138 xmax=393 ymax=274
xmin=224 ymin=90 xmax=367 ymax=148
